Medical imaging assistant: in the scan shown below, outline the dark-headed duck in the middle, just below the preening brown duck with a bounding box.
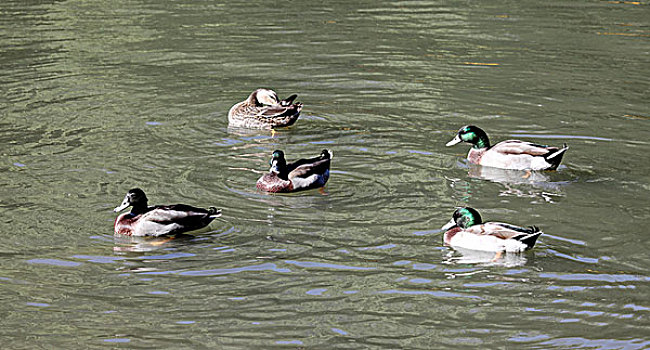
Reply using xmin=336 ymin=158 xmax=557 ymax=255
xmin=257 ymin=149 xmax=334 ymax=193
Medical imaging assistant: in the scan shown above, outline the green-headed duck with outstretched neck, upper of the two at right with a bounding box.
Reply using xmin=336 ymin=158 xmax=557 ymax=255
xmin=446 ymin=125 xmax=569 ymax=170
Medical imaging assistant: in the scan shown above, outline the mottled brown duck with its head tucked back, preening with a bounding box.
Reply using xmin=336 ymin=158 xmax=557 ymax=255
xmin=228 ymin=89 xmax=302 ymax=129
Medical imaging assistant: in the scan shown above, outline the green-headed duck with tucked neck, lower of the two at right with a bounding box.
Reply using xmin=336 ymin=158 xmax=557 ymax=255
xmin=441 ymin=207 xmax=543 ymax=253
